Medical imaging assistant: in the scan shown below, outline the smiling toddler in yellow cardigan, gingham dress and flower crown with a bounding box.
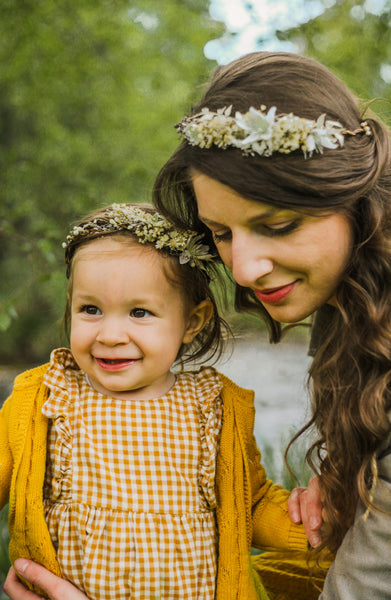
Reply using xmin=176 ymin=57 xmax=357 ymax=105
xmin=0 ymin=204 xmax=306 ymax=600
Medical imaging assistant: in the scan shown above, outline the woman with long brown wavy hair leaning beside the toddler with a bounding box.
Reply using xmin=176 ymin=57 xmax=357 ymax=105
xmin=7 ymin=53 xmax=391 ymax=600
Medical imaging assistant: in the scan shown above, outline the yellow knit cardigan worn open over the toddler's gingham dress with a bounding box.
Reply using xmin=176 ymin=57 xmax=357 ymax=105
xmin=0 ymin=364 xmax=316 ymax=600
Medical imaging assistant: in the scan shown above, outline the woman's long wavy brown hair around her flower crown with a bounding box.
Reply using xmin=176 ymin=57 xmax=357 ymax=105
xmin=154 ymin=52 xmax=391 ymax=551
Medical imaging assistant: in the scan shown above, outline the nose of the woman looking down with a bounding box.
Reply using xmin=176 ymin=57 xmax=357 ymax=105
xmin=231 ymin=235 xmax=274 ymax=288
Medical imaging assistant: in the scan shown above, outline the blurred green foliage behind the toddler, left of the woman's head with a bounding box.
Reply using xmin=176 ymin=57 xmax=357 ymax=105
xmin=0 ymin=0 xmax=223 ymax=364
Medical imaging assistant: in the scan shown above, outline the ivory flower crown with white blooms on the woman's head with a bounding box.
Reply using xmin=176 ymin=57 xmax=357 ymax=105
xmin=175 ymin=105 xmax=372 ymax=158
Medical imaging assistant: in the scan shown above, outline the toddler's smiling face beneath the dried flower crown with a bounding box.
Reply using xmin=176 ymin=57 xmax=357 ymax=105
xmin=71 ymin=237 xmax=196 ymax=399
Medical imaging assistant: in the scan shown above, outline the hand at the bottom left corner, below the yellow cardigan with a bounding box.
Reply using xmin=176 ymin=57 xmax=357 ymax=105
xmin=3 ymin=558 xmax=88 ymax=600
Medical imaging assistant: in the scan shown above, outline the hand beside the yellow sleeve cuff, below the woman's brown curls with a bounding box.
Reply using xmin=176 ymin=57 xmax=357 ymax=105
xmin=288 ymin=477 xmax=323 ymax=548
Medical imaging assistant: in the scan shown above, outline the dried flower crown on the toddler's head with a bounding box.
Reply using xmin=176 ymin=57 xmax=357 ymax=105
xmin=62 ymin=204 xmax=215 ymax=271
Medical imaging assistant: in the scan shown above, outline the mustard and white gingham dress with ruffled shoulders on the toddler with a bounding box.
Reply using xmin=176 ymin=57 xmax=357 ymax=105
xmin=43 ymin=349 xmax=222 ymax=600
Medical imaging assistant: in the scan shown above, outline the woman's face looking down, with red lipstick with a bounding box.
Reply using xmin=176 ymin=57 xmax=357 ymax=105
xmin=192 ymin=171 xmax=353 ymax=323
